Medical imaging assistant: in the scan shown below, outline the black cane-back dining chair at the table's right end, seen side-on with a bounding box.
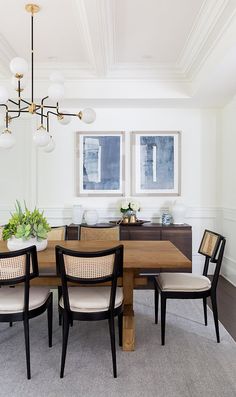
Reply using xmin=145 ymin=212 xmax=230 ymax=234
xmin=154 ymin=230 xmax=226 ymax=345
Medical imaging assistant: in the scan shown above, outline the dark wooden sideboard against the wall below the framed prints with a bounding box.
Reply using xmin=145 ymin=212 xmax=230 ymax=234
xmin=67 ymin=223 xmax=192 ymax=260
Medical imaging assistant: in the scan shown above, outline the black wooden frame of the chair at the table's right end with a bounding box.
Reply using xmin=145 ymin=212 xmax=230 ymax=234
xmin=154 ymin=230 xmax=226 ymax=345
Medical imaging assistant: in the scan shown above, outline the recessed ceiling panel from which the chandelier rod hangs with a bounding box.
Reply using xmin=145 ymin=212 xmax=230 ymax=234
xmin=0 ymin=0 xmax=88 ymax=63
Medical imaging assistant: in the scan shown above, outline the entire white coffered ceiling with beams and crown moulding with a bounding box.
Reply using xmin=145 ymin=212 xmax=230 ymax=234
xmin=0 ymin=0 xmax=236 ymax=107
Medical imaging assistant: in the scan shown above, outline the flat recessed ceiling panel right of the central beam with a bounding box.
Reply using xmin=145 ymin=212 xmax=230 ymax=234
xmin=113 ymin=0 xmax=204 ymax=64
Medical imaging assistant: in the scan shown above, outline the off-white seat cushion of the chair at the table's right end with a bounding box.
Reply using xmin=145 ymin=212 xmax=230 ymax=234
xmin=157 ymin=273 xmax=211 ymax=292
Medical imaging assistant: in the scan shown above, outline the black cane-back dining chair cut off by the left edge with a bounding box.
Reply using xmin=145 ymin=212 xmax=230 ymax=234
xmin=0 ymin=246 xmax=52 ymax=379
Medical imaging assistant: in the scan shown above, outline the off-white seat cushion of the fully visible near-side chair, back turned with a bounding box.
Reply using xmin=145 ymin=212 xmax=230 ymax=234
xmin=59 ymin=287 xmax=123 ymax=313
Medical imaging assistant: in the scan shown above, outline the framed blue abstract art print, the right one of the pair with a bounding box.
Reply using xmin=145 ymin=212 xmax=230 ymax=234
xmin=131 ymin=131 xmax=180 ymax=196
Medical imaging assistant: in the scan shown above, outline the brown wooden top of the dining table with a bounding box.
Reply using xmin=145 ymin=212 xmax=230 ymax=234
xmin=0 ymin=240 xmax=192 ymax=273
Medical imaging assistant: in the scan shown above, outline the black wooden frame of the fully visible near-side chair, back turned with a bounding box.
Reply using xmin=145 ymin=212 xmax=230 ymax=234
xmin=56 ymin=245 xmax=123 ymax=378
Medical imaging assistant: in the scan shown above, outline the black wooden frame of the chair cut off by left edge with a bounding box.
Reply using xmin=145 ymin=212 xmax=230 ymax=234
xmin=0 ymin=245 xmax=53 ymax=379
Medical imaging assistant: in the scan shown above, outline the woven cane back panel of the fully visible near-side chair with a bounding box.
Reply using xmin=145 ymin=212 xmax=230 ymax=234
xmin=64 ymin=254 xmax=115 ymax=279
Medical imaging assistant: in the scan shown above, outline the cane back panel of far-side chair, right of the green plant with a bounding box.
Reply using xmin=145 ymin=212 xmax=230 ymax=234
xmin=80 ymin=226 xmax=120 ymax=241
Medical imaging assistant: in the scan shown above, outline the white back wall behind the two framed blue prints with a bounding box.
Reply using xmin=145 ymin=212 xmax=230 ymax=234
xmin=0 ymin=108 xmax=220 ymax=272
